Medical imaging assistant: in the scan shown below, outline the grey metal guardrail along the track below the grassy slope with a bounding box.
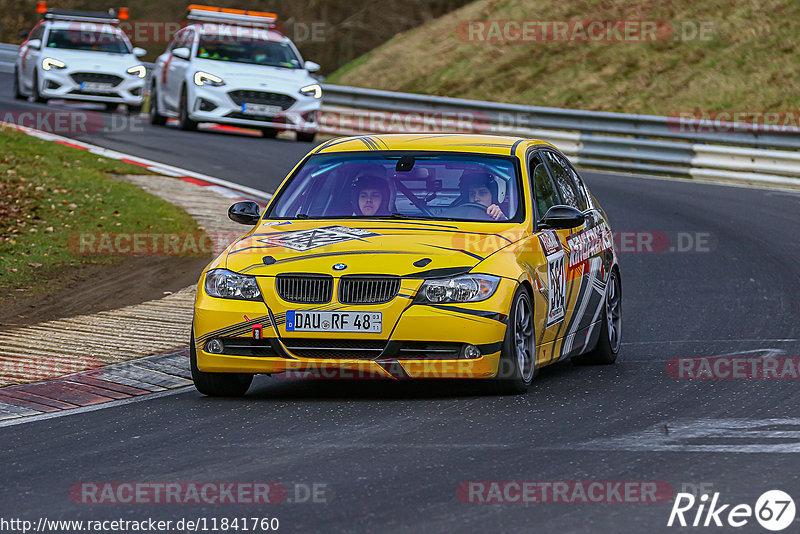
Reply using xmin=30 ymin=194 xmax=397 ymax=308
xmin=0 ymin=44 xmax=800 ymax=185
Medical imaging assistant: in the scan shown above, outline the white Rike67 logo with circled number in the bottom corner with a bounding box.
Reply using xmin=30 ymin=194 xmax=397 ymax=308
xmin=667 ymin=490 xmax=795 ymax=532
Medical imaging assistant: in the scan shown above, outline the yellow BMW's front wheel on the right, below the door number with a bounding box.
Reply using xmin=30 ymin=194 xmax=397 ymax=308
xmin=495 ymin=286 xmax=538 ymax=395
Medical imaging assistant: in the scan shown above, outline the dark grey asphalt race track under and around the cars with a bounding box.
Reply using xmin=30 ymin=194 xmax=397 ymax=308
xmin=0 ymin=72 xmax=800 ymax=533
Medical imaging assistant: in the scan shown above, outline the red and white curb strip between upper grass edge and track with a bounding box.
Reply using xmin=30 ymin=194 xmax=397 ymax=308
xmin=0 ymin=122 xmax=272 ymax=206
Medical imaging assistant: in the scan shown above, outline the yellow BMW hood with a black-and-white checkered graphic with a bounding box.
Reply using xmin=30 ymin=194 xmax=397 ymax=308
xmin=225 ymin=219 xmax=522 ymax=277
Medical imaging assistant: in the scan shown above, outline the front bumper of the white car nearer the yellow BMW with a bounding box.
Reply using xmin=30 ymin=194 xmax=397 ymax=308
xmin=189 ymin=85 xmax=322 ymax=133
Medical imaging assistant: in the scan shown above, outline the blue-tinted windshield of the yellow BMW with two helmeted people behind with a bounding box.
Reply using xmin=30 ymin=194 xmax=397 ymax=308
xmin=267 ymin=154 xmax=523 ymax=222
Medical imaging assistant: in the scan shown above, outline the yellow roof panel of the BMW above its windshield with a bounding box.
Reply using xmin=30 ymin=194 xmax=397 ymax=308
xmin=314 ymin=133 xmax=553 ymax=156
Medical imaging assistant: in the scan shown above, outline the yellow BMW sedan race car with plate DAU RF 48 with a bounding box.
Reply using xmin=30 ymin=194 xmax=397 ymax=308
xmin=190 ymin=134 xmax=622 ymax=396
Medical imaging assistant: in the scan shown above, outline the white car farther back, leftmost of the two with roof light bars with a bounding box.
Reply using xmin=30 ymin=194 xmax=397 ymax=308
xmin=14 ymin=9 xmax=147 ymax=113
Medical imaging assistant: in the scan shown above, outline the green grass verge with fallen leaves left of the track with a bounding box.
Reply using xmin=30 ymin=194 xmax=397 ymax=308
xmin=0 ymin=127 xmax=197 ymax=303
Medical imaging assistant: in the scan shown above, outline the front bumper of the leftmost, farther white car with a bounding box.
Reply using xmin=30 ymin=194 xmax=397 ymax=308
xmin=39 ymin=68 xmax=145 ymax=106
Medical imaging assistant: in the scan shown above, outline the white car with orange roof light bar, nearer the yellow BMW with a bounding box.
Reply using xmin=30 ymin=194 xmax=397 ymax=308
xmin=150 ymin=6 xmax=322 ymax=142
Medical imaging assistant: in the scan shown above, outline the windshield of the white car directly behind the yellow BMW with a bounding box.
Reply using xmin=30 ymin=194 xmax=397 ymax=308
xmin=197 ymin=34 xmax=301 ymax=69
